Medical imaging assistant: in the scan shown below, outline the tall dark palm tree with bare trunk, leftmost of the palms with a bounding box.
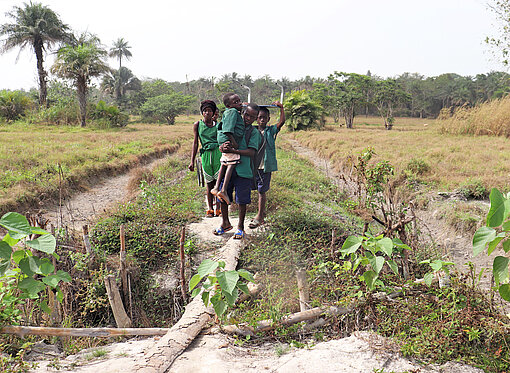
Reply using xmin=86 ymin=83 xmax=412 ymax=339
xmin=0 ymin=2 xmax=69 ymax=106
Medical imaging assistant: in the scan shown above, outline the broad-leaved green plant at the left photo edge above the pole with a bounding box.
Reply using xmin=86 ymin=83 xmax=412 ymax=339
xmin=0 ymin=212 xmax=71 ymax=321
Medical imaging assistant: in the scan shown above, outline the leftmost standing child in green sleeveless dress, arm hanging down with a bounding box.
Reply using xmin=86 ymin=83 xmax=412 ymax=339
xmin=188 ymin=100 xmax=221 ymax=218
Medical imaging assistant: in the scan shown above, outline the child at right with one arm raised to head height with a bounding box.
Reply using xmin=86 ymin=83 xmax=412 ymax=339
xmin=248 ymin=101 xmax=285 ymax=229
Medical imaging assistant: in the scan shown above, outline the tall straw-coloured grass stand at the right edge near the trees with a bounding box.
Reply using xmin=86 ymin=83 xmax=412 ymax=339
xmin=440 ymin=96 xmax=510 ymax=137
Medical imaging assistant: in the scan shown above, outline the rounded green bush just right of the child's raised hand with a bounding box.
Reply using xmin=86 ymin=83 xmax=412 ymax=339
xmin=285 ymin=90 xmax=325 ymax=131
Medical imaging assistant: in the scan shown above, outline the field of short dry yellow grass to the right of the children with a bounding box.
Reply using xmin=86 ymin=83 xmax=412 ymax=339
xmin=287 ymin=116 xmax=510 ymax=190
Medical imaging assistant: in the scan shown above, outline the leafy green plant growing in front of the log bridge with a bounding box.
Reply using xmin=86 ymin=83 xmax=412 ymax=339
xmin=189 ymin=259 xmax=255 ymax=317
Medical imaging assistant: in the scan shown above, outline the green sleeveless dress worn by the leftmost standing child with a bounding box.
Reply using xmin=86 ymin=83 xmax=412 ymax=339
xmin=198 ymin=120 xmax=221 ymax=183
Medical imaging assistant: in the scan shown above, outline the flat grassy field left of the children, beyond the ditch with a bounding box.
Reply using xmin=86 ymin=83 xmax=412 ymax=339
xmin=0 ymin=116 xmax=197 ymax=212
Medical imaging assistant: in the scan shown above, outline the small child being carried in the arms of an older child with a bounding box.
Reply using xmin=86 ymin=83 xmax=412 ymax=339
xmin=211 ymin=93 xmax=245 ymax=205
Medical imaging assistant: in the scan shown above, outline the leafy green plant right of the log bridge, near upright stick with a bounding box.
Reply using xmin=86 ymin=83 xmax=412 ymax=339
xmin=340 ymin=235 xmax=411 ymax=290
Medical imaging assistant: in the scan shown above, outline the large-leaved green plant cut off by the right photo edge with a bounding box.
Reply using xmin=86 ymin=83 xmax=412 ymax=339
xmin=473 ymin=188 xmax=510 ymax=302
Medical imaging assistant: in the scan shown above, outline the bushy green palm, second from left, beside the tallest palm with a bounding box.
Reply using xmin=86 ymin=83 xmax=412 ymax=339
xmin=51 ymin=33 xmax=110 ymax=127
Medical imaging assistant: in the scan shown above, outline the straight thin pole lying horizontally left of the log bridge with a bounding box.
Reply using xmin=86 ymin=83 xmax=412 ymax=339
xmin=0 ymin=325 xmax=170 ymax=337
